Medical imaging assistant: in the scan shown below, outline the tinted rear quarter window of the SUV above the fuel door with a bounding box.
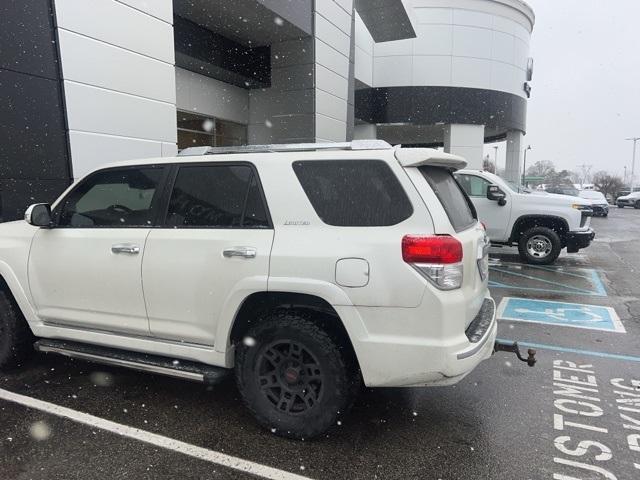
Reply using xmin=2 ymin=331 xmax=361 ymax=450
xmin=293 ymin=160 xmax=413 ymax=227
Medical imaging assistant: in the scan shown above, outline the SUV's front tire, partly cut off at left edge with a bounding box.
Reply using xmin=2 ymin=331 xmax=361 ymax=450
xmin=0 ymin=291 xmax=34 ymax=370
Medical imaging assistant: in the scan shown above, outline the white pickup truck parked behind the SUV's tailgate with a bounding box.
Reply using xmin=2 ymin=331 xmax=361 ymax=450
xmin=455 ymin=170 xmax=595 ymax=265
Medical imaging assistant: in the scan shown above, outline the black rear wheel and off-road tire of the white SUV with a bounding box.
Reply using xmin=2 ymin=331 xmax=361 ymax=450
xmin=235 ymin=310 xmax=361 ymax=439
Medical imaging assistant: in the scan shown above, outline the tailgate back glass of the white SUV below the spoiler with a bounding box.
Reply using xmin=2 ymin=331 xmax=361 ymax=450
xmin=419 ymin=167 xmax=477 ymax=232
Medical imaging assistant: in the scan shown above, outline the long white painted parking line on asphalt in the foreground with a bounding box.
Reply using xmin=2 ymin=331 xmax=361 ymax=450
xmin=0 ymin=388 xmax=310 ymax=480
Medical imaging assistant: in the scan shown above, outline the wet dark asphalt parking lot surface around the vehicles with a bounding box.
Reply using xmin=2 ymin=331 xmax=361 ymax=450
xmin=0 ymin=208 xmax=640 ymax=480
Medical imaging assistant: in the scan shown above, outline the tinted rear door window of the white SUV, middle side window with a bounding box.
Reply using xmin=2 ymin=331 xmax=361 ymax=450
xmin=166 ymin=165 xmax=270 ymax=228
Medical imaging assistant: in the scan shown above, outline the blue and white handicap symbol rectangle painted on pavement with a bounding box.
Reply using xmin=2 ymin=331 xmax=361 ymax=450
xmin=498 ymin=297 xmax=626 ymax=333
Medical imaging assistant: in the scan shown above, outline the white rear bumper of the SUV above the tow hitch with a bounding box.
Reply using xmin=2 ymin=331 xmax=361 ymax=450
xmin=344 ymin=297 xmax=498 ymax=387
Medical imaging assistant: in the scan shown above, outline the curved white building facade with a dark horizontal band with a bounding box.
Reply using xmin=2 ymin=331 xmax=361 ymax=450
xmin=355 ymin=0 xmax=535 ymax=180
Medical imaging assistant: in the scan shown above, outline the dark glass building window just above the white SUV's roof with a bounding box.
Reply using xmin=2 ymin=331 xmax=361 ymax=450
xmin=178 ymin=111 xmax=247 ymax=150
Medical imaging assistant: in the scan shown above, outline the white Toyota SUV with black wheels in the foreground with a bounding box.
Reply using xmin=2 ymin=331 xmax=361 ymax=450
xmin=0 ymin=142 xmax=496 ymax=438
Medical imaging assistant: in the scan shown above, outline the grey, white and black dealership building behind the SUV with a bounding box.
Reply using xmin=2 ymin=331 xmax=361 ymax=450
xmin=0 ymin=0 xmax=534 ymax=221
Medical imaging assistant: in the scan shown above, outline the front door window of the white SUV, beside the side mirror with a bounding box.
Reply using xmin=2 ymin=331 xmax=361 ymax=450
xmin=57 ymin=167 xmax=164 ymax=228
